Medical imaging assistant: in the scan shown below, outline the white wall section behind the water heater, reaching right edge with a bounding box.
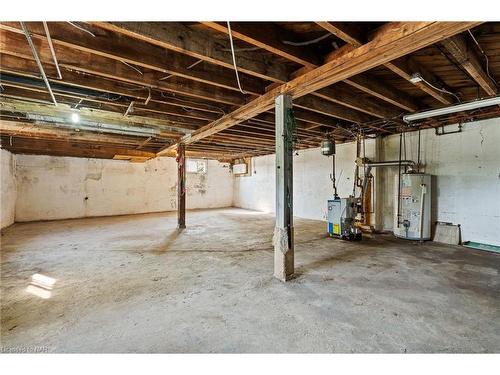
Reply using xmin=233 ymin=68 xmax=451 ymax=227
xmin=383 ymin=118 xmax=500 ymax=245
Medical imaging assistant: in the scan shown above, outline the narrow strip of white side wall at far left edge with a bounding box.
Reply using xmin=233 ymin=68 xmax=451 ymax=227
xmin=0 ymin=150 xmax=17 ymax=228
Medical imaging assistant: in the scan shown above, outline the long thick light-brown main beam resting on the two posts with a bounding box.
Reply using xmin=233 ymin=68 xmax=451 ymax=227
xmin=156 ymin=22 xmax=479 ymax=153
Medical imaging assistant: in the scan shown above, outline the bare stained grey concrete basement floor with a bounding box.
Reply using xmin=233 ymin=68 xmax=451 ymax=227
xmin=1 ymin=209 xmax=500 ymax=353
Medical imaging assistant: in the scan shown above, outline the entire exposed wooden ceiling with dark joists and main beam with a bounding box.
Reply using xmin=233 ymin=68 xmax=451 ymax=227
xmin=0 ymin=22 xmax=494 ymax=162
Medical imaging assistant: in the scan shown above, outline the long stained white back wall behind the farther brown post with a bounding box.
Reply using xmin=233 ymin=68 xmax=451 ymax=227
xmin=15 ymin=155 xmax=233 ymax=221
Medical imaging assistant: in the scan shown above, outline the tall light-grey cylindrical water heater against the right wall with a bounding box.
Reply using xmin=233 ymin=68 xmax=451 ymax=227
xmin=394 ymin=173 xmax=431 ymax=240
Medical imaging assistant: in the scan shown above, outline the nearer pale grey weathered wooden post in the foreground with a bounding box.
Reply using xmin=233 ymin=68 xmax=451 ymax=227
xmin=273 ymin=94 xmax=294 ymax=281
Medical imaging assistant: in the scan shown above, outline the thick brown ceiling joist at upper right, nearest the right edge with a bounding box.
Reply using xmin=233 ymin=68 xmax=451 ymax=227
xmin=441 ymin=35 xmax=498 ymax=95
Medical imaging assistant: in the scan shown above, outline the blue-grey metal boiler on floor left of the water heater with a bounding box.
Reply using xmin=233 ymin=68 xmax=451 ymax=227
xmin=327 ymin=197 xmax=361 ymax=239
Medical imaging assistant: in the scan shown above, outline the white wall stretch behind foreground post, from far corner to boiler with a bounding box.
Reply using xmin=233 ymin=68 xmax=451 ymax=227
xmin=234 ymin=140 xmax=375 ymax=220
